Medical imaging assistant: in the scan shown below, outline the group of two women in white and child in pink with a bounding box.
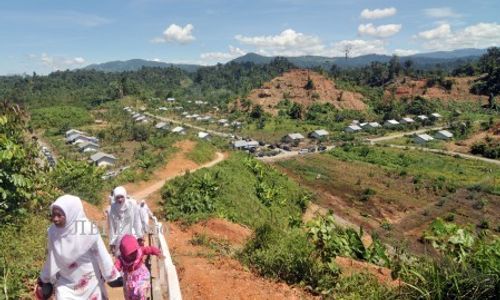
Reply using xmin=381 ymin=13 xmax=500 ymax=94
xmin=35 ymin=187 xmax=162 ymax=300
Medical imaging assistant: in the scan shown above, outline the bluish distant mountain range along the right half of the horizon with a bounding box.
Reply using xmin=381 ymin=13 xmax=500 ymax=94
xmin=232 ymin=49 xmax=486 ymax=69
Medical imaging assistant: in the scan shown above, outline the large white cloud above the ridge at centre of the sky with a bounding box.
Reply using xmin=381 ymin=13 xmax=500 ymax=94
xmin=235 ymin=29 xmax=325 ymax=56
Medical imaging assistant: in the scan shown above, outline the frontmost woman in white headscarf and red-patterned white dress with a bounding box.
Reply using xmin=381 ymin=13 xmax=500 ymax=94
xmin=36 ymin=195 xmax=119 ymax=300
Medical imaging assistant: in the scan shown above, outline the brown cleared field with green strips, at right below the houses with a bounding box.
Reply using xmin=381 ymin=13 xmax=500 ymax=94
xmin=276 ymin=148 xmax=500 ymax=252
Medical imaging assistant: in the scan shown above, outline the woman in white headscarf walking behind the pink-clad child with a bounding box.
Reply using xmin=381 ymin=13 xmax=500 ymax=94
xmin=108 ymin=186 xmax=144 ymax=255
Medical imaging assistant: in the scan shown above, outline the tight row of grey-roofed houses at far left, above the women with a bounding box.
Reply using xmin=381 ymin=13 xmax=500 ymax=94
xmin=65 ymin=129 xmax=116 ymax=167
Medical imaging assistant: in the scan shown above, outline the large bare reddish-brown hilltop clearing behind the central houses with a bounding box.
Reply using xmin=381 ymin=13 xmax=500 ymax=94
xmin=247 ymin=69 xmax=366 ymax=114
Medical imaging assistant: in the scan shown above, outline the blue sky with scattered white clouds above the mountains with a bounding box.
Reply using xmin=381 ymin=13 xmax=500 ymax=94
xmin=0 ymin=0 xmax=500 ymax=75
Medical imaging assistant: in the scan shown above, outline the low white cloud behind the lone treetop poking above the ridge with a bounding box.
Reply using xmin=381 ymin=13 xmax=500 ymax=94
xmin=329 ymin=40 xmax=387 ymax=57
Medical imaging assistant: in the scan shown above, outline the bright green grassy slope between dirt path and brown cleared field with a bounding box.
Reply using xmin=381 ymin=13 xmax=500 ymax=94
xmin=162 ymin=153 xmax=304 ymax=228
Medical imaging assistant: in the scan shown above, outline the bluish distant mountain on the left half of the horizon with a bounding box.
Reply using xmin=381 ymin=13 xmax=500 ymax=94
xmin=83 ymin=59 xmax=200 ymax=72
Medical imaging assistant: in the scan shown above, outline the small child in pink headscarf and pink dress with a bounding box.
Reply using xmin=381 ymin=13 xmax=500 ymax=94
xmin=115 ymin=234 xmax=162 ymax=300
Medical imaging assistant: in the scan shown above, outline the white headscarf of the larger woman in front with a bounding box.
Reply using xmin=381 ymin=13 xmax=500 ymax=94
xmin=48 ymin=195 xmax=99 ymax=270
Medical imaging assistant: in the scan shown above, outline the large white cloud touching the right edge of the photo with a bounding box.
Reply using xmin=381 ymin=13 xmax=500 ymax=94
xmin=417 ymin=23 xmax=500 ymax=50
